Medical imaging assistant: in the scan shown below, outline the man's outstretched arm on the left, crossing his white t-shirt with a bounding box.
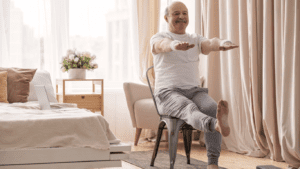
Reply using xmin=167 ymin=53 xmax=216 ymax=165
xmin=152 ymin=38 xmax=195 ymax=54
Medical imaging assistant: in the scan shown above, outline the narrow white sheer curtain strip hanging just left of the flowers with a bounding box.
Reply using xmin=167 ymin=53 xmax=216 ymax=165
xmin=41 ymin=0 xmax=69 ymax=83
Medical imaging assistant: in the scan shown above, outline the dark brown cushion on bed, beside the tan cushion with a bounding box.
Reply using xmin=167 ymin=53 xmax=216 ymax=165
xmin=0 ymin=68 xmax=36 ymax=103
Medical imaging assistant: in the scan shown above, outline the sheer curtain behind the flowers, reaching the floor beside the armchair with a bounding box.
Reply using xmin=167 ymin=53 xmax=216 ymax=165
xmin=67 ymin=0 xmax=141 ymax=142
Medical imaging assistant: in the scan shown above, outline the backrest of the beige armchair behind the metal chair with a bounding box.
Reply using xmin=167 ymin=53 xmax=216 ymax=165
xmin=123 ymin=82 xmax=152 ymax=127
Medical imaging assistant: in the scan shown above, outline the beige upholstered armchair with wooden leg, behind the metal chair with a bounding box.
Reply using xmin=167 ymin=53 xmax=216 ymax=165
xmin=123 ymin=83 xmax=160 ymax=146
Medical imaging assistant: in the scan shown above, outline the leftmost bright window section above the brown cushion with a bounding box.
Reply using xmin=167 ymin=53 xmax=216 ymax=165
xmin=4 ymin=0 xmax=44 ymax=68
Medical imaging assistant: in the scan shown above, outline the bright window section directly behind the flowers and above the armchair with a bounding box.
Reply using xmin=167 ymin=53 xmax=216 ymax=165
xmin=69 ymin=0 xmax=138 ymax=86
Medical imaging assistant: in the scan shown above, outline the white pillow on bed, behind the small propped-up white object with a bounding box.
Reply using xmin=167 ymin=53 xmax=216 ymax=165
xmin=28 ymin=70 xmax=57 ymax=103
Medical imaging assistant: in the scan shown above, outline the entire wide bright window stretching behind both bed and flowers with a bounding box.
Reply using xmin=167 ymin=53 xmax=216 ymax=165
xmin=0 ymin=0 xmax=139 ymax=88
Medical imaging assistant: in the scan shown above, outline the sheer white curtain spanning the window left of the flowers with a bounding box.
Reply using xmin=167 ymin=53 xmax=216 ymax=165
xmin=0 ymin=0 xmax=69 ymax=84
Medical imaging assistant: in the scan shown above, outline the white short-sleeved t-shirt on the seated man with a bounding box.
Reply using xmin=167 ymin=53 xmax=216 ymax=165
xmin=150 ymin=31 xmax=206 ymax=90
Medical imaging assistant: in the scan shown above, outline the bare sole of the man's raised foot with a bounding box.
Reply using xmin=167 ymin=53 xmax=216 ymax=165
xmin=215 ymin=100 xmax=230 ymax=137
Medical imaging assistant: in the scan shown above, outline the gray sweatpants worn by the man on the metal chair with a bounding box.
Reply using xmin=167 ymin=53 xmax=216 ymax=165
xmin=154 ymin=87 xmax=222 ymax=165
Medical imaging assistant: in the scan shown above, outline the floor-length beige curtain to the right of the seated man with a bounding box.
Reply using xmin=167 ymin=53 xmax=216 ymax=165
xmin=196 ymin=0 xmax=300 ymax=168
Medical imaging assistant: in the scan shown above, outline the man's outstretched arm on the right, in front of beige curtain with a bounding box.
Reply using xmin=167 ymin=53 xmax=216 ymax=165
xmin=201 ymin=38 xmax=239 ymax=55
